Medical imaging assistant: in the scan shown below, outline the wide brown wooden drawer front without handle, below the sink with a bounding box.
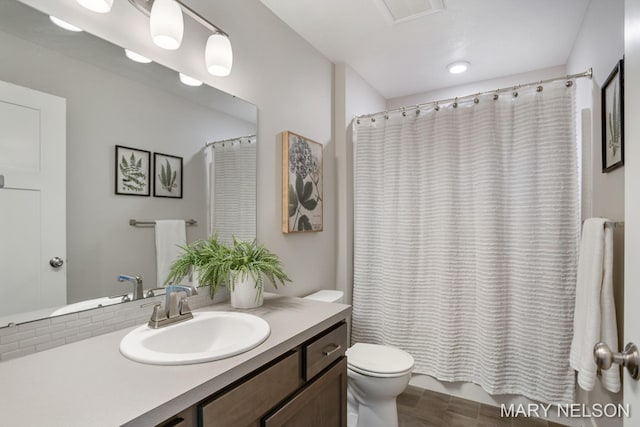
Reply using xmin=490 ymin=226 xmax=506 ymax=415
xmin=198 ymin=351 xmax=302 ymax=427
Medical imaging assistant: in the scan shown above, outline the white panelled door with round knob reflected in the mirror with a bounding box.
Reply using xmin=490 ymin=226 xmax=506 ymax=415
xmin=0 ymin=82 xmax=67 ymax=318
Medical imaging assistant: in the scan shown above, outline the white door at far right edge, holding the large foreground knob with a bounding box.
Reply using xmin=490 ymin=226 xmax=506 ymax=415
xmin=618 ymin=0 xmax=640 ymax=427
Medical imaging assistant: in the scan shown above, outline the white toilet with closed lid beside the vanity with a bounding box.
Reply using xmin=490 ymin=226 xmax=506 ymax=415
xmin=305 ymin=290 xmax=414 ymax=427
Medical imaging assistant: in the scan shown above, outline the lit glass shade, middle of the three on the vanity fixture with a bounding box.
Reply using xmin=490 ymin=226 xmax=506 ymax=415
xmin=149 ymin=0 xmax=184 ymax=50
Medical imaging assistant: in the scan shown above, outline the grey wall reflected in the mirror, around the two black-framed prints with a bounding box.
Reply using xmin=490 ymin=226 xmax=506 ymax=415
xmin=0 ymin=32 xmax=255 ymax=303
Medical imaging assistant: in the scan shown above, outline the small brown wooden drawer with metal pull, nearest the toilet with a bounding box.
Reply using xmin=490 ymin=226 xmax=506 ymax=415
xmin=302 ymin=322 xmax=347 ymax=381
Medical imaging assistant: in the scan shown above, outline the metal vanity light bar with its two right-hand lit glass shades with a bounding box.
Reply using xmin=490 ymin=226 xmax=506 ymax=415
xmin=126 ymin=0 xmax=233 ymax=77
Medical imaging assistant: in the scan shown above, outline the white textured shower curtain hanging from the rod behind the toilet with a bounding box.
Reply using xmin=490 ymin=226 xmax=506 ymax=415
xmin=352 ymin=81 xmax=579 ymax=403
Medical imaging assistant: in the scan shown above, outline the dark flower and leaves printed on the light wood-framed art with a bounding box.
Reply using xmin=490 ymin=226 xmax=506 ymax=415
xmin=289 ymin=135 xmax=322 ymax=231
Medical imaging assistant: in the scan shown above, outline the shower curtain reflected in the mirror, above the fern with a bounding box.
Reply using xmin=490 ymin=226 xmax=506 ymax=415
xmin=205 ymin=136 xmax=256 ymax=243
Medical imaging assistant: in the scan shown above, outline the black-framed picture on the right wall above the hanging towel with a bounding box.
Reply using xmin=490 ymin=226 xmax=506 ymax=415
xmin=602 ymin=59 xmax=624 ymax=172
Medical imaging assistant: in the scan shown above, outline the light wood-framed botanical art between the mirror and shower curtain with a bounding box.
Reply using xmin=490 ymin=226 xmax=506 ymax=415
xmin=282 ymin=131 xmax=322 ymax=233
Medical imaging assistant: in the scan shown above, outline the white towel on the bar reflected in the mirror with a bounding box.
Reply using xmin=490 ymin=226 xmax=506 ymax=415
xmin=156 ymin=220 xmax=187 ymax=288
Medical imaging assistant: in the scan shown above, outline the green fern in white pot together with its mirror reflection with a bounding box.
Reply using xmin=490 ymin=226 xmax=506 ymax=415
xmin=167 ymin=236 xmax=291 ymax=308
